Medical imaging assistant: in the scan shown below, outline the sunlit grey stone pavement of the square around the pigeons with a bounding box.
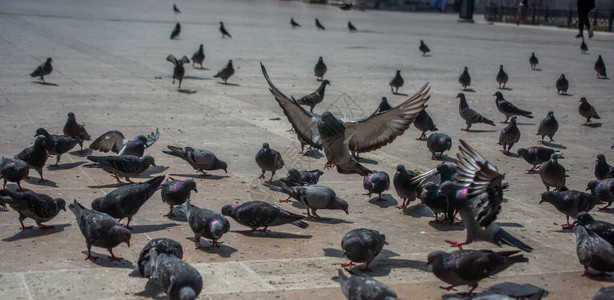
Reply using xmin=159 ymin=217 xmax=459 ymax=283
xmin=0 ymin=0 xmax=614 ymax=299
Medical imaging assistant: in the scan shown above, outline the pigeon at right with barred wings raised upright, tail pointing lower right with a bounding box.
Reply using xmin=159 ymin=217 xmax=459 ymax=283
xmin=439 ymin=140 xmax=533 ymax=252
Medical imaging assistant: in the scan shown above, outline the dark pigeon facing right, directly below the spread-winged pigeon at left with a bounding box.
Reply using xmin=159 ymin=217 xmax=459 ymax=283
xmin=84 ymin=155 xmax=156 ymax=183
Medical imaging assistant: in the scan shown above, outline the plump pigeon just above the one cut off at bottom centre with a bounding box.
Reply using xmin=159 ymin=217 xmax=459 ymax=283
xmin=341 ymin=228 xmax=388 ymax=272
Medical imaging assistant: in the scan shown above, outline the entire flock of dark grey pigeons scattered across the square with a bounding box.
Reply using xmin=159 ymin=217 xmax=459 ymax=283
xmin=0 ymin=5 xmax=614 ymax=299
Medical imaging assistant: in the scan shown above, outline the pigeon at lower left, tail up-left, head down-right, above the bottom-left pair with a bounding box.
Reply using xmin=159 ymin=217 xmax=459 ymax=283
xmin=68 ymin=200 xmax=131 ymax=260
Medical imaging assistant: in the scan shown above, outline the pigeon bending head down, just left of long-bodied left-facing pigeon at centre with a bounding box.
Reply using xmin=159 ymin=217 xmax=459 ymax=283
xmin=185 ymin=200 xmax=230 ymax=249
